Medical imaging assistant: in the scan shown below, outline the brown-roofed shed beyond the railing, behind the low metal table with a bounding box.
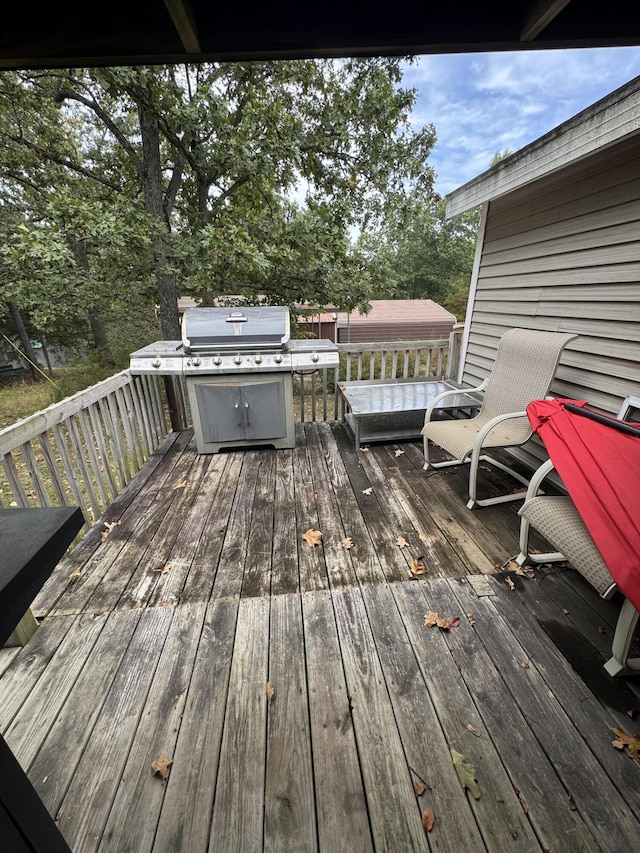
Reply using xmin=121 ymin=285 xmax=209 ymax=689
xmin=338 ymin=299 xmax=456 ymax=344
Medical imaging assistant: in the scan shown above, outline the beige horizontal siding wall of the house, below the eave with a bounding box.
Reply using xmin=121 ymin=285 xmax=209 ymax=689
xmin=463 ymin=136 xmax=640 ymax=470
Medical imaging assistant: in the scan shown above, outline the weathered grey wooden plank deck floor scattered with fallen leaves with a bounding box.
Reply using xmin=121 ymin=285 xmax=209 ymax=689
xmin=0 ymin=423 xmax=640 ymax=853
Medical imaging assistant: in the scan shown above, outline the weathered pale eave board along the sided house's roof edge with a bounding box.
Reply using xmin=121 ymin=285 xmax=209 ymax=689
xmin=446 ymin=77 xmax=640 ymax=218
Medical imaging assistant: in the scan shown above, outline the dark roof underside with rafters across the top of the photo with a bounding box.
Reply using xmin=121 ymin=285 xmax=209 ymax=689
xmin=0 ymin=0 xmax=640 ymax=69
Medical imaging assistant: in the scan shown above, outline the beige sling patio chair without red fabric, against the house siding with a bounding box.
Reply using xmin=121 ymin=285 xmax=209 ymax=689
xmin=422 ymin=329 xmax=578 ymax=509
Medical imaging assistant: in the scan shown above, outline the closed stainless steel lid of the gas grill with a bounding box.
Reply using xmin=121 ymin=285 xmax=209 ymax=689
xmin=182 ymin=305 xmax=290 ymax=352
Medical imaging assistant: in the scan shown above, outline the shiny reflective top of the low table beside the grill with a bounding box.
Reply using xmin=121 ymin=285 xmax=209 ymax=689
xmin=339 ymin=379 xmax=480 ymax=416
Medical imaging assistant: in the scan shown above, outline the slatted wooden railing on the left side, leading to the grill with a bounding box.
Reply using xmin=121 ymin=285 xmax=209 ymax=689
xmin=0 ymin=370 xmax=169 ymax=529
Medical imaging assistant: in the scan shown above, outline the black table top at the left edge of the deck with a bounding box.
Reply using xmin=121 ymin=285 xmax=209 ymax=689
xmin=0 ymin=507 xmax=84 ymax=646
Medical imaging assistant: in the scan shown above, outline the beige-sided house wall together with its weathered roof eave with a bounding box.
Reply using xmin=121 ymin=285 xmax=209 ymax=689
xmin=446 ymin=77 xmax=640 ymax=466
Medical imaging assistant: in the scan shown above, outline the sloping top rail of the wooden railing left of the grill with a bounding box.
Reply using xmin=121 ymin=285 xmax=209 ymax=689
xmin=0 ymin=370 xmax=133 ymax=459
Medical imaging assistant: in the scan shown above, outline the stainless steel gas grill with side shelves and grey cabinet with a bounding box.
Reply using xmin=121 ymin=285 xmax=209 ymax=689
xmin=131 ymin=306 xmax=338 ymax=453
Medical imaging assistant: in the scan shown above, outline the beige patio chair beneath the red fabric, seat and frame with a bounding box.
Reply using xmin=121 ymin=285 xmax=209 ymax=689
xmin=515 ymin=459 xmax=640 ymax=676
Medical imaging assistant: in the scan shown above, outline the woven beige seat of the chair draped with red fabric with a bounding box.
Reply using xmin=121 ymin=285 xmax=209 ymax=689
xmin=518 ymin=495 xmax=617 ymax=598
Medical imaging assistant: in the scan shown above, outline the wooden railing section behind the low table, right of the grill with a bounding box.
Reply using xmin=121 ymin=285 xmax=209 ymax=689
xmin=294 ymin=324 xmax=464 ymax=421
